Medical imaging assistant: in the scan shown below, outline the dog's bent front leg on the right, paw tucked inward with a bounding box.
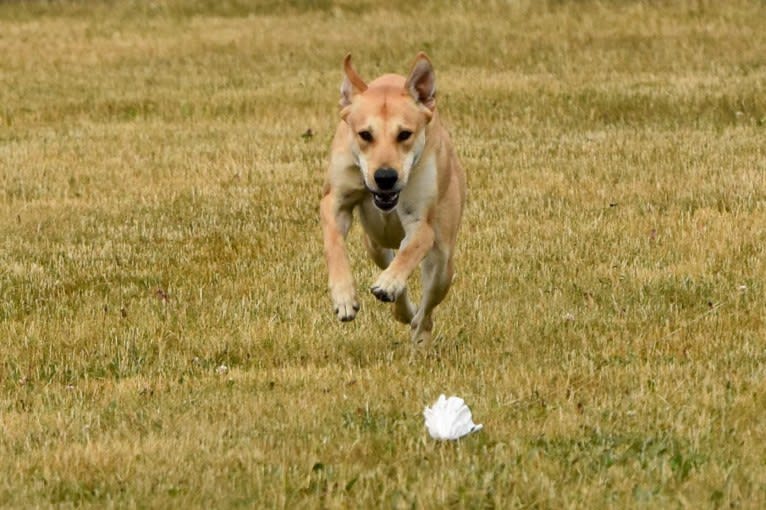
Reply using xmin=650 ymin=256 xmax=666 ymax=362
xmin=370 ymin=221 xmax=434 ymax=302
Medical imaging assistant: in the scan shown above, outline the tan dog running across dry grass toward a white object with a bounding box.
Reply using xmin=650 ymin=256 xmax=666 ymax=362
xmin=320 ymin=53 xmax=465 ymax=343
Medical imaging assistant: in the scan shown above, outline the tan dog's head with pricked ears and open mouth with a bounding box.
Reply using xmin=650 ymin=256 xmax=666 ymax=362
xmin=340 ymin=52 xmax=436 ymax=211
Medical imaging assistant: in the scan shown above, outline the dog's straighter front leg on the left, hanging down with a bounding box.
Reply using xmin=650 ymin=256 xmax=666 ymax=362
xmin=319 ymin=190 xmax=359 ymax=322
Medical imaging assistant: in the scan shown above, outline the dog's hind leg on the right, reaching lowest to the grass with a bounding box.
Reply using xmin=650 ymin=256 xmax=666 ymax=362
xmin=411 ymin=249 xmax=453 ymax=346
